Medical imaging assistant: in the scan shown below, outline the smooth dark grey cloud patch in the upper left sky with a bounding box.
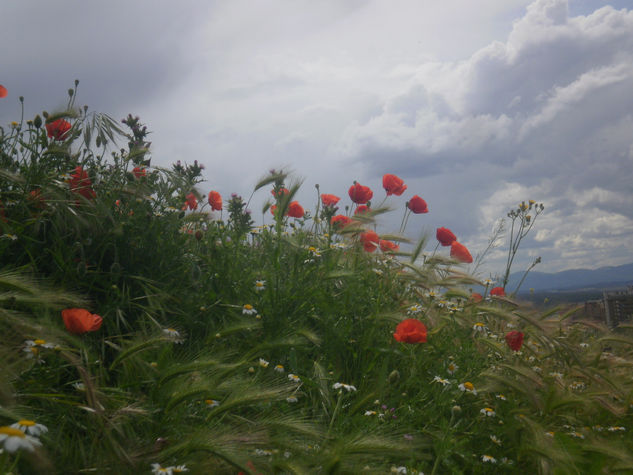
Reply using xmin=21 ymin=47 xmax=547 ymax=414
xmin=0 ymin=0 xmax=211 ymax=122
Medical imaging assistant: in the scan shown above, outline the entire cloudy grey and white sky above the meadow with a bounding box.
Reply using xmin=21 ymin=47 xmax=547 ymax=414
xmin=0 ymin=0 xmax=633 ymax=277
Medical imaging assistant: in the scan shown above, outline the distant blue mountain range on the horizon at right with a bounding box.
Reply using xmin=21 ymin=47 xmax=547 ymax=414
xmin=506 ymin=263 xmax=633 ymax=294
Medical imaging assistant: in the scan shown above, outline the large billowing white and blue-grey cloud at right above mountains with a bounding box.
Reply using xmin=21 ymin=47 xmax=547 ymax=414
xmin=330 ymin=0 xmax=633 ymax=270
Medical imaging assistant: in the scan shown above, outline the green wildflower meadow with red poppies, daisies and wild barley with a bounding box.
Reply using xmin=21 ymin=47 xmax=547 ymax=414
xmin=0 ymin=83 xmax=633 ymax=475
